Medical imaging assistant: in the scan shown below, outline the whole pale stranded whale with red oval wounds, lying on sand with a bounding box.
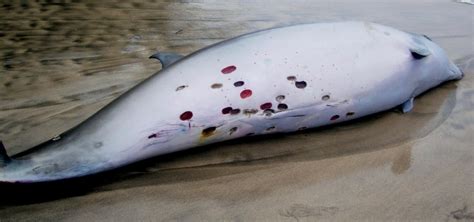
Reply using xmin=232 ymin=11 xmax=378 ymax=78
xmin=0 ymin=22 xmax=463 ymax=183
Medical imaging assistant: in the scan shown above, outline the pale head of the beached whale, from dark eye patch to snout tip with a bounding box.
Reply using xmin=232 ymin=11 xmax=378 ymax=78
xmin=410 ymin=34 xmax=464 ymax=93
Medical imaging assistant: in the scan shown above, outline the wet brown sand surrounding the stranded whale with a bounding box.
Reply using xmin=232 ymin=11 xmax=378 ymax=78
xmin=0 ymin=0 xmax=474 ymax=221
